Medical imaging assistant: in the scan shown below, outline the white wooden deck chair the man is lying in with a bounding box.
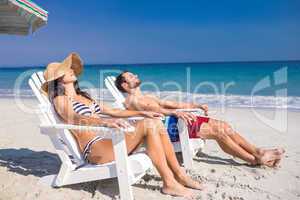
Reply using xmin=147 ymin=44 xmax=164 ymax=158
xmin=104 ymin=76 xmax=204 ymax=169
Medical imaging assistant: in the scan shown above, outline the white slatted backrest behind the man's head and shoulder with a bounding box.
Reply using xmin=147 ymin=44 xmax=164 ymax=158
xmin=104 ymin=76 xmax=125 ymax=108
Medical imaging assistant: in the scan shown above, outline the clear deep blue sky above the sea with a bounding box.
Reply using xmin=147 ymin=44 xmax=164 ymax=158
xmin=0 ymin=0 xmax=300 ymax=67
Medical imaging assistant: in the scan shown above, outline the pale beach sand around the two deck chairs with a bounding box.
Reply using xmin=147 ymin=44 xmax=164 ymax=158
xmin=0 ymin=99 xmax=300 ymax=200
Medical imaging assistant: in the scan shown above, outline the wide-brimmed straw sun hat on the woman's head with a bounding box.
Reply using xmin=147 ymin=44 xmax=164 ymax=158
xmin=41 ymin=53 xmax=83 ymax=94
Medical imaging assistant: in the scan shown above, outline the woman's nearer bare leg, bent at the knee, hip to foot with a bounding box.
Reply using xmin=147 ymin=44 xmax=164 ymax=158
xmin=89 ymin=119 xmax=192 ymax=197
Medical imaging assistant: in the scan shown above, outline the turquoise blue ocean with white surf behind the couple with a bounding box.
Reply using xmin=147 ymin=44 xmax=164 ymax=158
xmin=0 ymin=61 xmax=300 ymax=110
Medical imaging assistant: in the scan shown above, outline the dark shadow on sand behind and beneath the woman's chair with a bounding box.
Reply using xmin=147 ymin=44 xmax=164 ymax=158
xmin=0 ymin=148 xmax=119 ymax=198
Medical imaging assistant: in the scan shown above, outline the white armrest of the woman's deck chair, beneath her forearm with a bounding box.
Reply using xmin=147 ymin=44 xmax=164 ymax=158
xmin=40 ymin=124 xmax=134 ymax=138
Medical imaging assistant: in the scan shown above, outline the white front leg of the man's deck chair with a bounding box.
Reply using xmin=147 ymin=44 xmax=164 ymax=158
xmin=178 ymin=119 xmax=193 ymax=169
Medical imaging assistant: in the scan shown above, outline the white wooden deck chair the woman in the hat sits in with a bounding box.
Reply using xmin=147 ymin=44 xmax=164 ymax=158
xmin=29 ymin=72 xmax=153 ymax=200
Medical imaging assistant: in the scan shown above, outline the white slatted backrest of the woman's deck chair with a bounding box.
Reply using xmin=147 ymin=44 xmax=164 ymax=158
xmin=29 ymin=71 xmax=84 ymax=166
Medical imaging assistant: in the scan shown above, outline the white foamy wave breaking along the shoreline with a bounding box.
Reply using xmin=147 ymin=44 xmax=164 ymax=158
xmin=0 ymin=88 xmax=300 ymax=110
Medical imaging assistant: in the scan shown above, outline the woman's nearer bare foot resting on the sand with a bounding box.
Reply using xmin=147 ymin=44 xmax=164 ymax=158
xmin=162 ymin=180 xmax=194 ymax=199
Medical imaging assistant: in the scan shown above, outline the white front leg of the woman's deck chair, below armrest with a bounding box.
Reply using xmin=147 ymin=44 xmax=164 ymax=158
xmin=112 ymin=132 xmax=133 ymax=200
